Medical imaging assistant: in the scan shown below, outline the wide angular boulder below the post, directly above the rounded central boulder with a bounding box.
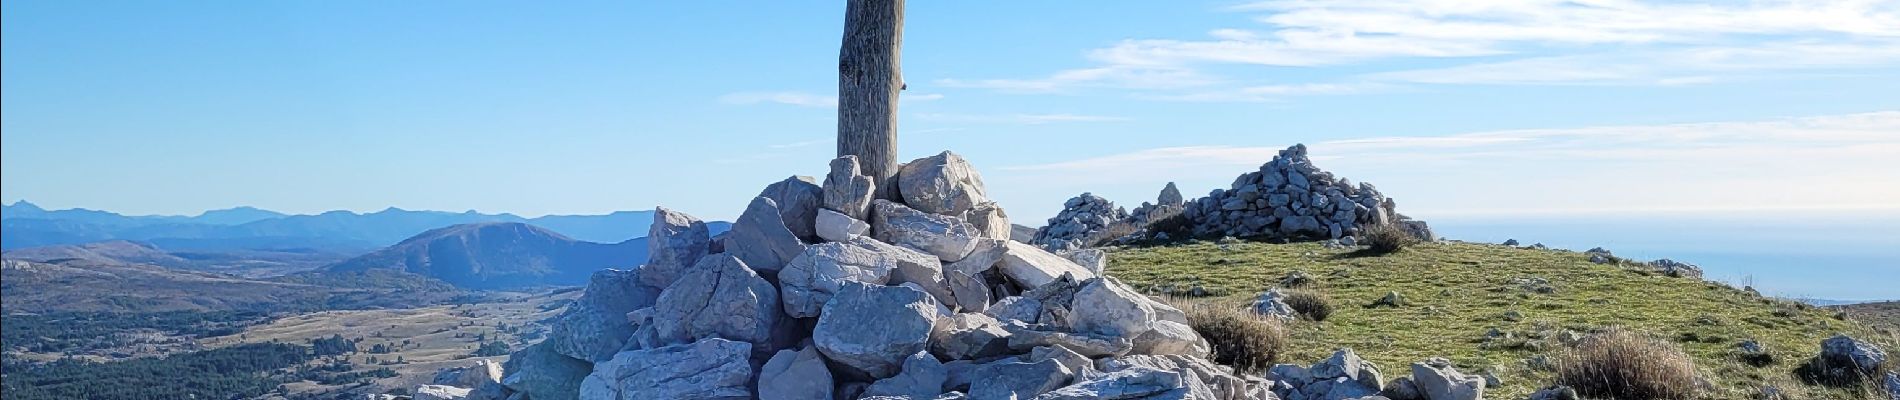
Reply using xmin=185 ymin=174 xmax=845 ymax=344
xmin=779 ymin=237 xmax=937 ymax=318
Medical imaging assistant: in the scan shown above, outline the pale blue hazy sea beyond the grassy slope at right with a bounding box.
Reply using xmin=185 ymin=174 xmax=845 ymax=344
xmin=1419 ymin=210 xmax=1900 ymax=301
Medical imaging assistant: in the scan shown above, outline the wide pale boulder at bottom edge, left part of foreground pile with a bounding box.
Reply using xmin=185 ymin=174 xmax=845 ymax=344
xmin=581 ymin=337 xmax=752 ymax=400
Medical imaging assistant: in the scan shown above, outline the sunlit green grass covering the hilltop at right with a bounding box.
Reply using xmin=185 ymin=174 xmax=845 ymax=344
xmin=1108 ymin=243 xmax=1900 ymax=398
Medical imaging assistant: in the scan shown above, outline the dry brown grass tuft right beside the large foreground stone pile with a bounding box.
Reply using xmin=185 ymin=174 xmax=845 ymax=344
xmin=1176 ymin=301 xmax=1288 ymax=372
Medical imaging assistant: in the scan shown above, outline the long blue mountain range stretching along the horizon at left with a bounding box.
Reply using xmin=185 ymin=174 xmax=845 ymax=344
xmin=0 ymin=201 xmax=654 ymax=252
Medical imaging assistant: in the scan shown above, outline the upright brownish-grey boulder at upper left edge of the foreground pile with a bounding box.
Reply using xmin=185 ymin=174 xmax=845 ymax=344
xmin=640 ymin=207 xmax=713 ymax=290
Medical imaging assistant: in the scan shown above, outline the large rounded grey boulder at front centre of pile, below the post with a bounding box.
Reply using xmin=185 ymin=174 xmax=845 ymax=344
xmin=811 ymin=282 xmax=939 ymax=379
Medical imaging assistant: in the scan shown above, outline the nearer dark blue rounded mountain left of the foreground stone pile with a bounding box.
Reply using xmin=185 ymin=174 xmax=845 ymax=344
xmin=323 ymin=222 xmax=648 ymax=288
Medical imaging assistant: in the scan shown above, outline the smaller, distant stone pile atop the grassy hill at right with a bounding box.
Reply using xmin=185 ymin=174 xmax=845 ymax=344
xmin=1184 ymin=144 xmax=1435 ymax=241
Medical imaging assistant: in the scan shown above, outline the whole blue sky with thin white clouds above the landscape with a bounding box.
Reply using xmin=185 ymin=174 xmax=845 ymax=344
xmin=0 ymin=0 xmax=1900 ymax=224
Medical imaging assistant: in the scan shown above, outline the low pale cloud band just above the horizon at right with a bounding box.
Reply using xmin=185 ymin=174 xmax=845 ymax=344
xmin=998 ymin=112 xmax=1900 ymax=216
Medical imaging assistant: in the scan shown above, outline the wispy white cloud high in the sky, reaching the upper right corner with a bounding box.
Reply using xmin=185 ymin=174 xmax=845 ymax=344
xmin=939 ymin=0 xmax=1900 ymax=100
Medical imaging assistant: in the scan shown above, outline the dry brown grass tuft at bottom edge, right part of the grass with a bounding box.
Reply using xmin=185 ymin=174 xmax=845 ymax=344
xmin=1556 ymin=328 xmax=1701 ymax=400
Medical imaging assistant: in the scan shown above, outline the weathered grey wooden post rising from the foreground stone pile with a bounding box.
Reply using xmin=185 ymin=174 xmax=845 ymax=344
xmin=838 ymin=0 xmax=904 ymax=199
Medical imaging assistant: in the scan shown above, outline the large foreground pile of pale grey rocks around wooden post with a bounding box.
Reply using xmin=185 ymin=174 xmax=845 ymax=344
xmin=467 ymin=152 xmax=1277 ymax=400
